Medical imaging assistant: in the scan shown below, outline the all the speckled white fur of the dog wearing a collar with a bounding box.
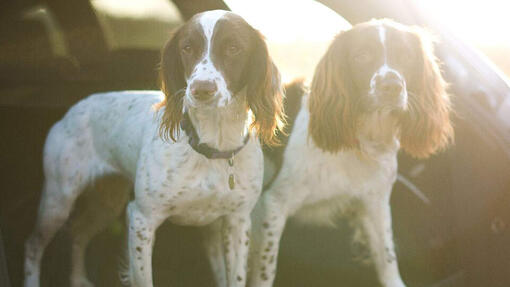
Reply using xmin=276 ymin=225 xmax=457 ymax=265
xmin=24 ymin=11 xmax=263 ymax=287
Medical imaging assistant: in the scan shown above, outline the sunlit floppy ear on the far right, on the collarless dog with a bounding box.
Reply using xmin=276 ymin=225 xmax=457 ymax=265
xmin=400 ymin=27 xmax=454 ymax=158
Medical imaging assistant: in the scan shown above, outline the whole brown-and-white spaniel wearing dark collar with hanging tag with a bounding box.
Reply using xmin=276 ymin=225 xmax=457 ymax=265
xmin=25 ymin=10 xmax=283 ymax=287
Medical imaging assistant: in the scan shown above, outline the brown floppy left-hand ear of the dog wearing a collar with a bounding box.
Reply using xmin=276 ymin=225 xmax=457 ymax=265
xmin=157 ymin=29 xmax=186 ymax=141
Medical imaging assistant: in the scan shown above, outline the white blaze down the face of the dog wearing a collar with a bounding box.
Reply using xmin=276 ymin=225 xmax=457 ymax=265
xmin=186 ymin=10 xmax=232 ymax=106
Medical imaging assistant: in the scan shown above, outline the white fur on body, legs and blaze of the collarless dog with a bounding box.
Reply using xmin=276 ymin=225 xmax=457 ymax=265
xmin=248 ymin=23 xmax=412 ymax=287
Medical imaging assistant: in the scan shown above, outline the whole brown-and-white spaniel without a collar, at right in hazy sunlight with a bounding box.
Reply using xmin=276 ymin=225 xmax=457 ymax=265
xmin=249 ymin=20 xmax=453 ymax=287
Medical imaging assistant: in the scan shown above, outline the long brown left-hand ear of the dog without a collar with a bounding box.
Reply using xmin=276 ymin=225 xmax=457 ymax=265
xmin=308 ymin=32 xmax=358 ymax=152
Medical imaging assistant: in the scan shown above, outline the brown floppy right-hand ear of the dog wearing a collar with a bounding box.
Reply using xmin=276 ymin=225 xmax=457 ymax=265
xmin=246 ymin=28 xmax=284 ymax=145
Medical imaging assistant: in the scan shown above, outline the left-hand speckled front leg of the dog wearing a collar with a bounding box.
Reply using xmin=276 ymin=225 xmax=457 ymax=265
xmin=126 ymin=201 xmax=165 ymax=287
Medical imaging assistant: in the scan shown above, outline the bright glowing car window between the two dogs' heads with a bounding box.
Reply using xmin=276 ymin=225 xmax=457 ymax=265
xmin=225 ymin=0 xmax=351 ymax=82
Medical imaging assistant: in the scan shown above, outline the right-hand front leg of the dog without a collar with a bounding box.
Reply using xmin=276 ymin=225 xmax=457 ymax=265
xmin=361 ymin=190 xmax=405 ymax=287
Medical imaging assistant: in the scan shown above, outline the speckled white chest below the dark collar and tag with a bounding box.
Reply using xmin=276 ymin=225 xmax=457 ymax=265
xmin=141 ymin=144 xmax=262 ymax=225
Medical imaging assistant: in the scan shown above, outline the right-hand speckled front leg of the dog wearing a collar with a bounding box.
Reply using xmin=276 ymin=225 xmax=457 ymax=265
xmin=223 ymin=213 xmax=251 ymax=287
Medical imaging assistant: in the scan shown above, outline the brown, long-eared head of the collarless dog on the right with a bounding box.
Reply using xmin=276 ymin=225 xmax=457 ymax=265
xmin=309 ymin=20 xmax=453 ymax=157
